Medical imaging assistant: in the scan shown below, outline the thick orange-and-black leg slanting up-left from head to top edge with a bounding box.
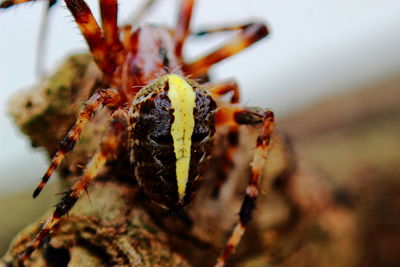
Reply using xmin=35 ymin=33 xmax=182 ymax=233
xmin=65 ymin=0 xmax=116 ymax=81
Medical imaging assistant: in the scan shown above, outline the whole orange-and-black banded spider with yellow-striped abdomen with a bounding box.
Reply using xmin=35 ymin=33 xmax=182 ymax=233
xmin=1 ymin=0 xmax=274 ymax=266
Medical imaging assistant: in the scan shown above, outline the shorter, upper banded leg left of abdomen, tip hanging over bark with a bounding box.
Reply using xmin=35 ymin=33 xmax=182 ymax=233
xmin=33 ymin=89 xmax=120 ymax=198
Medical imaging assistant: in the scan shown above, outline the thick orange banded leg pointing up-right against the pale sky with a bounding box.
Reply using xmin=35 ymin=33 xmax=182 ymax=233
xmin=183 ymin=23 xmax=268 ymax=78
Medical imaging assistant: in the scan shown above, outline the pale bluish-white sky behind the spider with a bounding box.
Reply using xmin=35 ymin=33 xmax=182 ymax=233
xmin=0 ymin=0 xmax=400 ymax=194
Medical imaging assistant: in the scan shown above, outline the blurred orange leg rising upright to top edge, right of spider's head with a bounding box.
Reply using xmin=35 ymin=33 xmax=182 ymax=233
xmin=175 ymin=0 xmax=194 ymax=58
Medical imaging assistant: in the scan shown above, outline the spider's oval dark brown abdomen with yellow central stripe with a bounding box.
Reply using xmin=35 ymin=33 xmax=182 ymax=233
xmin=130 ymin=74 xmax=216 ymax=210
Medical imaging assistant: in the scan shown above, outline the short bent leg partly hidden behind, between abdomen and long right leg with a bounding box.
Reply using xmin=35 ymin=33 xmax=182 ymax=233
xmin=207 ymin=80 xmax=240 ymax=198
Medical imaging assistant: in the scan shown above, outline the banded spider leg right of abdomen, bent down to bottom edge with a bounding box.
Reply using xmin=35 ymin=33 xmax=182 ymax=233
xmin=215 ymin=108 xmax=274 ymax=267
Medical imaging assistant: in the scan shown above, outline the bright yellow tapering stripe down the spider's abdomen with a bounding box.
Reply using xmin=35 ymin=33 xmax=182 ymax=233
xmin=168 ymin=74 xmax=196 ymax=201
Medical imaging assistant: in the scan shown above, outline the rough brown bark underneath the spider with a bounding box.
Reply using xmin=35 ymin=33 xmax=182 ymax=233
xmin=0 ymin=55 xmax=400 ymax=266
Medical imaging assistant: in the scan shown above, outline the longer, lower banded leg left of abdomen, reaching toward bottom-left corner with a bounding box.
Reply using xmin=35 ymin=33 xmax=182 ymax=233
xmin=21 ymin=109 xmax=127 ymax=261
